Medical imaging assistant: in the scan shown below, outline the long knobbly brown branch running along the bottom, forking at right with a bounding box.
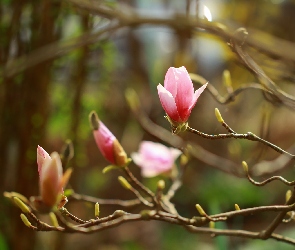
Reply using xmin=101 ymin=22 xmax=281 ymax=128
xmin=17 ymin=201 xmax=295 ymax=245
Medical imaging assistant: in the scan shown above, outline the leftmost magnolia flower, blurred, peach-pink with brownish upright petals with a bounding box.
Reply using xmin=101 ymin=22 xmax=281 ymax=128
xmin=34 ymin=146 xmax=72 ymax=212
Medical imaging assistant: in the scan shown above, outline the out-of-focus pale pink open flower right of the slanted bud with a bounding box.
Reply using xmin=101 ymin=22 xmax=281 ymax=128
xmin=131 ymin=141 xmax=181 ymax=177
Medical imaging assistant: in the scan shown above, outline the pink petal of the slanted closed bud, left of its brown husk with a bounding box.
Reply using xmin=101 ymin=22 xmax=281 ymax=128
xmin=93 ymin=121 xmax=116 ymax=164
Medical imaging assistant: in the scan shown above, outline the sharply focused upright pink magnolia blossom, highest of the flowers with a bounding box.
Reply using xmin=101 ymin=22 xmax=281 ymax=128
xmin=157 ymin=66 xmax=207 ymax=123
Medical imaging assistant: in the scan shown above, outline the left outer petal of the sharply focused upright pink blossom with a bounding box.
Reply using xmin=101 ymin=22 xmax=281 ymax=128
xmin=157 ymin=84 xmax=181 ymax=122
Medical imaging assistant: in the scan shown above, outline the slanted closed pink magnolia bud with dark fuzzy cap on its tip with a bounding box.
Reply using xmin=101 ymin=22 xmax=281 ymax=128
xmin=89 ymin=111 xmax=128 ymax=166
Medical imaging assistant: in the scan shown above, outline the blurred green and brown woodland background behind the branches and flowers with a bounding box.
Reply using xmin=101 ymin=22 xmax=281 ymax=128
xmin=0 ymin=0 xmax=295 ymax=250
